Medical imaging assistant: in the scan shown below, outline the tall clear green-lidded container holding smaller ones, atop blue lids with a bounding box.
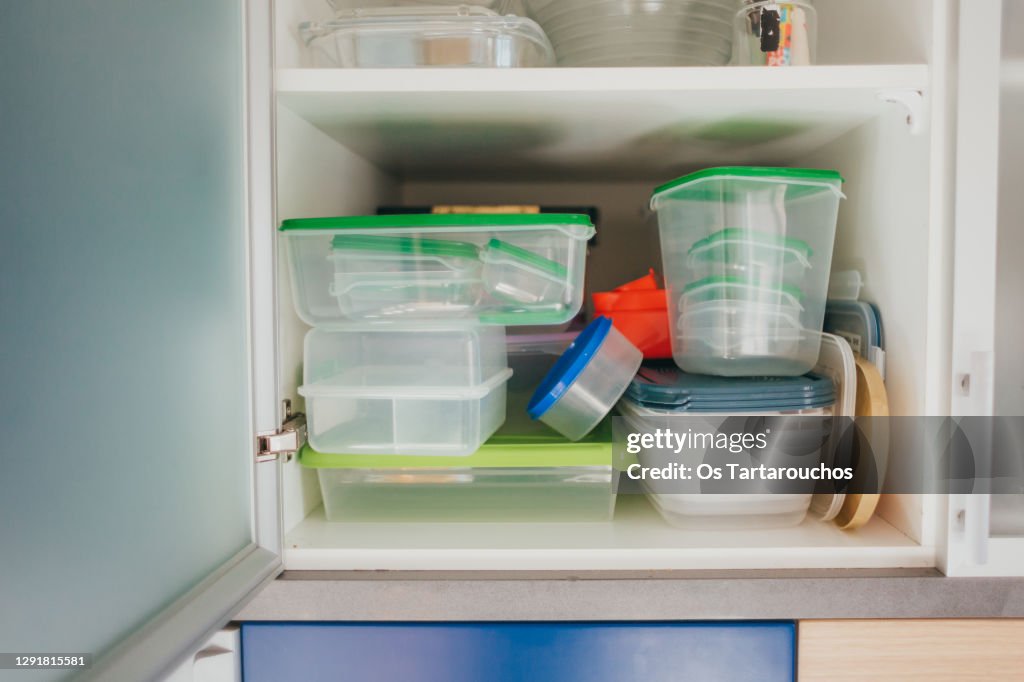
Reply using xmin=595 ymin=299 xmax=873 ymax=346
xmin=651 ymin=167 xmax=843 ymax=377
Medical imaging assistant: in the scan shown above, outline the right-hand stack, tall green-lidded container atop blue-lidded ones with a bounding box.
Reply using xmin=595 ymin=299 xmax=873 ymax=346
xmin=620 ymin=167 xmax=855 ymax=527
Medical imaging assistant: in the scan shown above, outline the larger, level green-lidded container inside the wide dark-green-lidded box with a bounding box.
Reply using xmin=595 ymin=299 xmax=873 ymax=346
xmin=329 ymin=235 xmax=482 ymax=319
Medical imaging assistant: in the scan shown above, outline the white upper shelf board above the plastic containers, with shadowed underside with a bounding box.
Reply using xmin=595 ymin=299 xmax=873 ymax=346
xmin=276 ymin=65 xmax=928 ymax=180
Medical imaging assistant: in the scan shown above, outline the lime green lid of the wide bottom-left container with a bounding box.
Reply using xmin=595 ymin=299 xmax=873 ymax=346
xmin=299 ymin=420 xmax=612 ymax=469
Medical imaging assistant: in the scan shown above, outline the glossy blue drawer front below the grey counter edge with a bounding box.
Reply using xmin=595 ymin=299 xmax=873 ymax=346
xmin=242 ymin=623 xmax=796 ymax=682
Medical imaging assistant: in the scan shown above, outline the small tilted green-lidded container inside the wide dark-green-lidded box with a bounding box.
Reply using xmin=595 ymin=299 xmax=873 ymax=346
xmin=480 ymin=240 xmax=568 ymax=308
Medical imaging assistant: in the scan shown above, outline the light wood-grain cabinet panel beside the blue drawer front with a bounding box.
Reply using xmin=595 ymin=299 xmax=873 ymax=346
xmin=797 ymin=620 xmax=1024 ymax=682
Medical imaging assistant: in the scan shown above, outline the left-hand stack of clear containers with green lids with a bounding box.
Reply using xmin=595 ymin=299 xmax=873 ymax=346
xmin=281 ymin=214 xmax=613 ymax=520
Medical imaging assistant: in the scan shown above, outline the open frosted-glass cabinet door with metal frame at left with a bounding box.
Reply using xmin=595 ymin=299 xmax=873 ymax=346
xmin=0 ymin=0 xmax=281 ymax=681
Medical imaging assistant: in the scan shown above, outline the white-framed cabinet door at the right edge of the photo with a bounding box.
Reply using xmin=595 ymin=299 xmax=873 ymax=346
xmin=942 ymin=0 xmax=1024 ymax=576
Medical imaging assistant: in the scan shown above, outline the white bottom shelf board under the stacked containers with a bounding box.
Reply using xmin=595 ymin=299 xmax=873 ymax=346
xmin=285 ymin=496 xmax=935 ymax=570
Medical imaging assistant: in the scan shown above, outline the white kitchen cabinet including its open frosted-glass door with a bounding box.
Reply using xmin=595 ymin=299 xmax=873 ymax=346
xmin=0 ymin=0 xmax=1024 ymax=679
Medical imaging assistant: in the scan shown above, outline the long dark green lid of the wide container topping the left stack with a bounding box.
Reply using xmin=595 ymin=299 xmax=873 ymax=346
xmin=281 ymin=213 xmax=594 ymax=233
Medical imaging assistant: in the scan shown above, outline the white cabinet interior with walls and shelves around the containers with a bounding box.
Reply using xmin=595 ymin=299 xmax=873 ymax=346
xmin=276 ymin=0 xmax=950 ymax=570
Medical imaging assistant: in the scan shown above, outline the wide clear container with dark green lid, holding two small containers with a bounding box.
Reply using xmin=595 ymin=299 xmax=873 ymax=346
xmin=281 ymin=213 xmax=594 ymax=326
